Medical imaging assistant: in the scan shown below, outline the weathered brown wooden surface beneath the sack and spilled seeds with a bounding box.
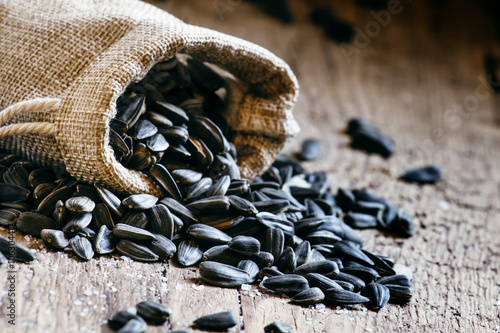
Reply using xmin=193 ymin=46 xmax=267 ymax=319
xmin=0 ymin=0 xmax=500 ymax=333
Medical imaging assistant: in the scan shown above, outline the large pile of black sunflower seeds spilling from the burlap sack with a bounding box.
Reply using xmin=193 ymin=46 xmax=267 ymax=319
xmin=0 ymin=53 xmax=415 ymax=310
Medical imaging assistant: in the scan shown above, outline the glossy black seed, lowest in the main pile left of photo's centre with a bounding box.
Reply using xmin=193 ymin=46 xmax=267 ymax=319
xmin=200 ymin=261 xmax=252 ymax=288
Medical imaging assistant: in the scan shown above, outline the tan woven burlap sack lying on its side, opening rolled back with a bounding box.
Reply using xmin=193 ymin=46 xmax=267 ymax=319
xmin=0 ymin=0 xmax=299 ymax=194
